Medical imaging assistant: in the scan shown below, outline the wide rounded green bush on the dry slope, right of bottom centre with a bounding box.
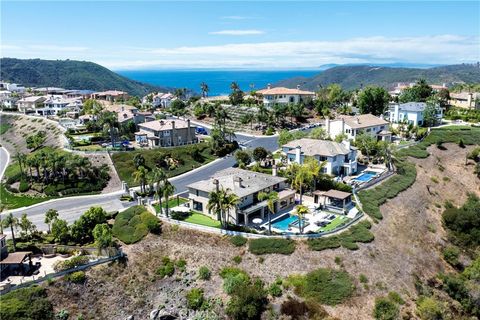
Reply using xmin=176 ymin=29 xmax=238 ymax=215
xmin=288 ymin=268 xmax=354 ymax=305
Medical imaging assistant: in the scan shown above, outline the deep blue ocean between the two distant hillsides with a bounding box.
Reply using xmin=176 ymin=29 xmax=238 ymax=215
xmin=117 ymin=70 xmax=320 ymax=96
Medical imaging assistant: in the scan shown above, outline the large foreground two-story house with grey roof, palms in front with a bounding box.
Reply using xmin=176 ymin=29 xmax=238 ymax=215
xmin=187 ymin=168 xmax=295 ymax=225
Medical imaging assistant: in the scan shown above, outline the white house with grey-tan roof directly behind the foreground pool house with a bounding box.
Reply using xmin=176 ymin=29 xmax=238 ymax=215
xmin=282 ymin=138 xmax=357 ymax=176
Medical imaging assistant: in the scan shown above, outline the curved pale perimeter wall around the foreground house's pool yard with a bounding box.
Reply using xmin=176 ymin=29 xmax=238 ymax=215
xmin=147 ymin=205 xmax=365 ymax=239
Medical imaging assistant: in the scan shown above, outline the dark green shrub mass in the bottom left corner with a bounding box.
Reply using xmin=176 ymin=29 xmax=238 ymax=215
xmin=0 ymin=285 xmax=54 ymax=320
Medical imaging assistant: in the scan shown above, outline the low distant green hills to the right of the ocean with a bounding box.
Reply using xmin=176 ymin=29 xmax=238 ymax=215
xmin=275 ymin=64 xmax=480 ymax=90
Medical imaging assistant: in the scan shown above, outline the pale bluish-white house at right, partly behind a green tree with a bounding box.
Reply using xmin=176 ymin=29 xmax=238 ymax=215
xmin=388 ymin=102 xmax=443 ymax=126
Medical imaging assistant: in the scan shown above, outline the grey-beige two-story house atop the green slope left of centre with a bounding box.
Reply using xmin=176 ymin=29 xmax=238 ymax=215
xmin=135 ymin=119 xmax=198 ymax=147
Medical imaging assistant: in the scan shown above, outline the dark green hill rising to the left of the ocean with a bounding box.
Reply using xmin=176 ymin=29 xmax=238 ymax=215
xmin=0 ymin=58 xmax=170 ymax=96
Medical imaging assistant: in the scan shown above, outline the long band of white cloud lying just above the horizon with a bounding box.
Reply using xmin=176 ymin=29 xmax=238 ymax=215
xmin=1 ymin=35 xmax=480 ymax=69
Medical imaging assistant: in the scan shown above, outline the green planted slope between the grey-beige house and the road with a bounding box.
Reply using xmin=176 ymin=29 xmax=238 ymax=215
xmin=112 ymin=143 xmax=216 ymax=187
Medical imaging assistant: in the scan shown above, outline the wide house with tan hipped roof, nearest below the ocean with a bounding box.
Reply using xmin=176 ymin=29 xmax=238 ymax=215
xmin=257 ymin=85 xmax=315 ymax=106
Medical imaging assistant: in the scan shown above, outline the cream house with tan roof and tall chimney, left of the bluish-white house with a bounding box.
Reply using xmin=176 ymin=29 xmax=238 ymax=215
xmin=325 ymin=114 xmax=392 ymax=141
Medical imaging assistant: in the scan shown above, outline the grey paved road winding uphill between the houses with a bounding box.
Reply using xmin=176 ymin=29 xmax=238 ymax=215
xmin=0 ymin=133 xmax=278 ymax=235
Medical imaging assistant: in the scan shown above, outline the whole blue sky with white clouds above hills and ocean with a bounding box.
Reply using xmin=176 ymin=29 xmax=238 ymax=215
xmin=0 ymin=0 xmax=480 ymax=70
